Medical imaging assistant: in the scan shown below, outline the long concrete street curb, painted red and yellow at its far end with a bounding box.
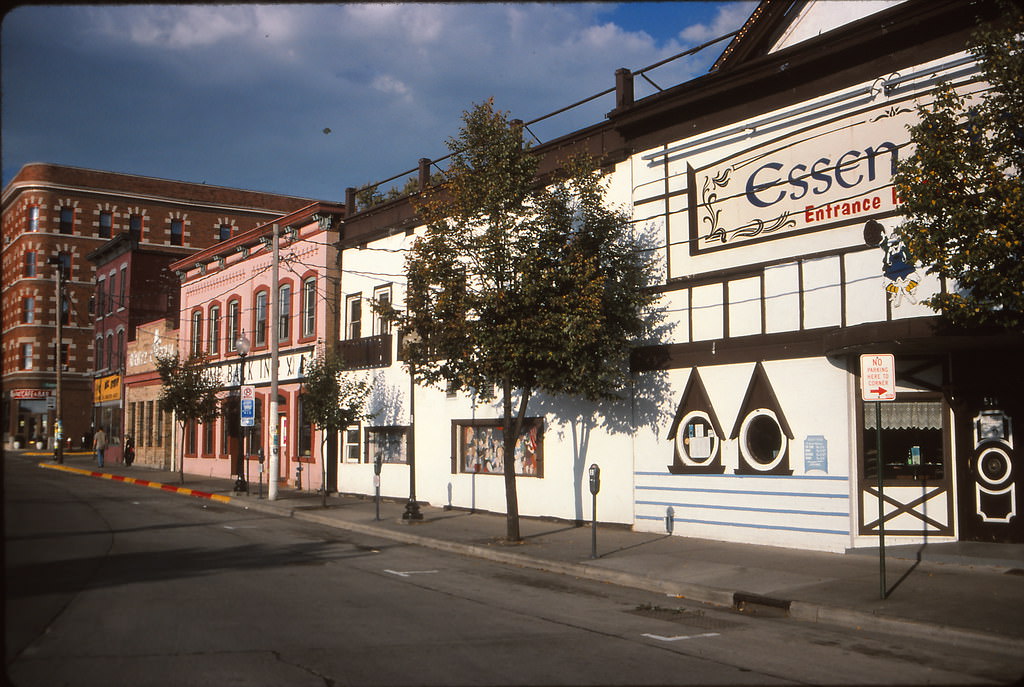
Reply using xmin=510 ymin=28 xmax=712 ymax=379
xmin=38 ymin=463 xmax=1024 ymax=654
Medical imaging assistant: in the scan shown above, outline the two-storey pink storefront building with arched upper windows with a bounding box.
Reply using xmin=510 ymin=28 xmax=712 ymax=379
xmin=171 ymin=203 xmax=344 ymax=490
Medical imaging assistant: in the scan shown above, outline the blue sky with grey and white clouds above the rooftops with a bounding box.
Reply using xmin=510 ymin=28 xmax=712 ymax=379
xmin=0 ymin=0 xmax=757 ymax=202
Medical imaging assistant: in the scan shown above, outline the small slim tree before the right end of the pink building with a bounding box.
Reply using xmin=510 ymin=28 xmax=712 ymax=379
xmin=302 ymin=351 xmax=370 ymax=507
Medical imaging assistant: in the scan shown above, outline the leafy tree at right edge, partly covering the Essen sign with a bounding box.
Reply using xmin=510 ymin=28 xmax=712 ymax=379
xmin=895 ymin=3 xmax=1024 ymax=330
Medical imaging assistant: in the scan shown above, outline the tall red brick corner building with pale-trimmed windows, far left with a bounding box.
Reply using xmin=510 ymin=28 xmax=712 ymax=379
xmin=0 ymin=163 xmax=319 ymax=447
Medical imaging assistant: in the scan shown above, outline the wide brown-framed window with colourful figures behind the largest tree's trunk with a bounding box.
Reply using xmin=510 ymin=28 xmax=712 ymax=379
xmin=455 ymin=418 xmax=544 ymax=477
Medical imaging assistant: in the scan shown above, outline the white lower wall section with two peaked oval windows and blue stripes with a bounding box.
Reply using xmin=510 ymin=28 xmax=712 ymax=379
xmin=634 ymin=358 xmax=856 ymax=551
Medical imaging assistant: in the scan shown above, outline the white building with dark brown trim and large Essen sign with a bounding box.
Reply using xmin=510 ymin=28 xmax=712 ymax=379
xmin=338 ymin=0 xmax=1024 ymax=551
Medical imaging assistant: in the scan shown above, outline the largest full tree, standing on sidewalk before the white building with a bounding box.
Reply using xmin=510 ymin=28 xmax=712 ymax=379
xmin=393 ymin=100 xmax=652 ymax=542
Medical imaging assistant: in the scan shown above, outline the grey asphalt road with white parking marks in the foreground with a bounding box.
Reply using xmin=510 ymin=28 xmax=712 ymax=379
xmin=4 ymin=457 xmax=1021 ymax=687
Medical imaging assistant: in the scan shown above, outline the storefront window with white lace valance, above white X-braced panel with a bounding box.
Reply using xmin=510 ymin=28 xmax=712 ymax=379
xmin=863 ymin=400 xmax=945 ymax=479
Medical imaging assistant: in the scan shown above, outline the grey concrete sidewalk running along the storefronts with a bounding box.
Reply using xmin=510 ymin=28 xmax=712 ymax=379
xmin=36 ymin=454 xmax=1024 ymax=655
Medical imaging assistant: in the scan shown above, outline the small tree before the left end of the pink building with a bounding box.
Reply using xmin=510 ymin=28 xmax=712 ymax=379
xmin=157 ymin=351 xmax=220 ymax=483
